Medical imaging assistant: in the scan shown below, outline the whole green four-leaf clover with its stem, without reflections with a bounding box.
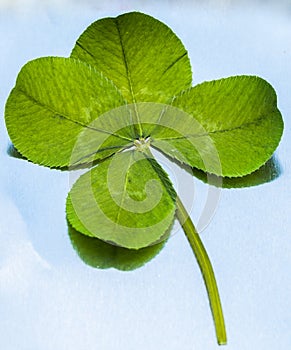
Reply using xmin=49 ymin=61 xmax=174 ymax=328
xmin=5 ymin=12 xmax=283 ymax=344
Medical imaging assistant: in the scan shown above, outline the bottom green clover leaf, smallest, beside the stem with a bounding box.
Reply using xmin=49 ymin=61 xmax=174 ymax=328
xmin=67 ymin=151 xmax=175 ymax=249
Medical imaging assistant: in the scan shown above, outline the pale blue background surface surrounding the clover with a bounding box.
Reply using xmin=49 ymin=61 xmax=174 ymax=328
xmin=0 ymin=0 xmax=291 ymax=350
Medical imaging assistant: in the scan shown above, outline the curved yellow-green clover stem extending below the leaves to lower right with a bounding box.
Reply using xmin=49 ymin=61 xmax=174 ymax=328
xmin=176 ymin=196 xmax=227 ymax=345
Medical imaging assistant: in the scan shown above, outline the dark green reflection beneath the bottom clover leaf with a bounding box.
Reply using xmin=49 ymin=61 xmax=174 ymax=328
xmin=68 ymin=224 xmax=166 ymax=271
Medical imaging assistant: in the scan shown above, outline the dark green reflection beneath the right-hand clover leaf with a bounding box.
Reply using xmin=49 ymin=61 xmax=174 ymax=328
xmin=192 ymin=156 xmax=282 ymax=188
